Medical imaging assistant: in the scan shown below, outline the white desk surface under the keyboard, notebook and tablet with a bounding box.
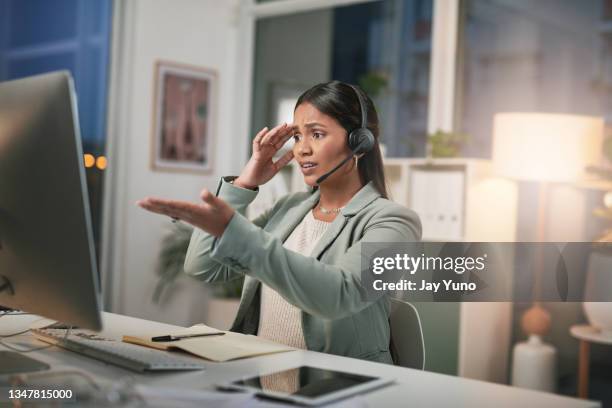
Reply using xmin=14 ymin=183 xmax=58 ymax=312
xmin=0 ymin=313 xmax=601 ymax=408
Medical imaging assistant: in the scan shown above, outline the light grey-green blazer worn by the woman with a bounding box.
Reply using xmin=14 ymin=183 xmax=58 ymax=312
xmin=185 ymin=178 xmax=421 ymax=363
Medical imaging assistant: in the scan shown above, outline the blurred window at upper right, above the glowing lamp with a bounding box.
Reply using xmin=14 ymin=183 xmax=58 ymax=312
xmin=456 ymin=0 xmax=612 ymax=158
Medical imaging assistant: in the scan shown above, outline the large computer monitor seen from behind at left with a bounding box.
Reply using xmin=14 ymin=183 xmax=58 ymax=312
xmin=0 ymin=71 xmax=102 ymax=330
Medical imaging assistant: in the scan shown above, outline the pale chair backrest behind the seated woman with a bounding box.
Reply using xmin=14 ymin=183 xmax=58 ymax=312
xmin=389 ymin=298 xmax=425 ymax=370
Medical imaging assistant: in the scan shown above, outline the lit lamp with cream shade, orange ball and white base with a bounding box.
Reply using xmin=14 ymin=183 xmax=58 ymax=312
xmin=493 ymin=112 xmax=604 ymax=391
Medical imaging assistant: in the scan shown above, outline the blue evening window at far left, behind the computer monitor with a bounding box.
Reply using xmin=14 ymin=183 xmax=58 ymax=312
xmin=0 ymin=0 xmax=111 ymax=260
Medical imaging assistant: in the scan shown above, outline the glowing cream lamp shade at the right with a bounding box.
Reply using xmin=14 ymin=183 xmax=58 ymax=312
xmin=493 ymin=113 xmax=604 ymax=182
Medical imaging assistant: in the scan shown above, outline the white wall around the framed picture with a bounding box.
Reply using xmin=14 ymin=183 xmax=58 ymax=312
xmin=101 ymin=0 xmax=243 ymax=324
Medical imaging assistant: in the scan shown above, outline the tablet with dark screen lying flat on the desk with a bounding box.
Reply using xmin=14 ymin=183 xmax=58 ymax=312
xmin=219 ymin=366 xmax=393 ymax=405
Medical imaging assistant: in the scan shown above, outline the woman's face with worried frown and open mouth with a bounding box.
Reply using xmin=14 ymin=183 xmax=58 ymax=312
xmin=293 ymin=102 xmax=353 ymax=186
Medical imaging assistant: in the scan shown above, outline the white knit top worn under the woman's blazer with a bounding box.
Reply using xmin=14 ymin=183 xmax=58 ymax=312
xmin=257 ymin=211 xmax=331 ymax=349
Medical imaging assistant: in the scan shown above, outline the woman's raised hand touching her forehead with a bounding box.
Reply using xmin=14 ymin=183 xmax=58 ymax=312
xmin=234 ymin=123 xmax=296 ymax=189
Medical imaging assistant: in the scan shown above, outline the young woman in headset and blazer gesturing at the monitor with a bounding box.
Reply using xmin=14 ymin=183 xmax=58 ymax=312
xmin=139 ymin=81 xmax=421 ymax=363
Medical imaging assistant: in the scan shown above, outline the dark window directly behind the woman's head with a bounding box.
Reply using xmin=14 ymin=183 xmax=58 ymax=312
xmin=251 ymin=0 xmax=433 ymax=157
